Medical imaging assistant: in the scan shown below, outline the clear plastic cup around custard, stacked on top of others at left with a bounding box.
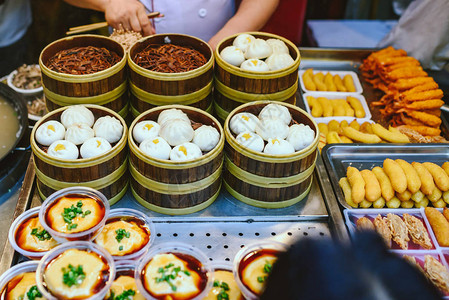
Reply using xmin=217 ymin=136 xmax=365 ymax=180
xmin=39 ymin=186 xmax=110 ymax=243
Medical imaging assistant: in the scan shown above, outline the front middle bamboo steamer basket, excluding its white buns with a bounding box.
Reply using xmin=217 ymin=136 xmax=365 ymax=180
xmin=128 ymin=105 xmax=225 ymax=215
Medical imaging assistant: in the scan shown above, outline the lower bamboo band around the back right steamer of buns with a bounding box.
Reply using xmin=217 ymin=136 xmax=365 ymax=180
xmin=215 ymin=78 xmax=298 ymax=103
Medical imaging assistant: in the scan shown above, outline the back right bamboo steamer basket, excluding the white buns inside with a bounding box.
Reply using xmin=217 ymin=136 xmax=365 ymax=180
xmin=214 ymin=32 xmax=301 ymax=121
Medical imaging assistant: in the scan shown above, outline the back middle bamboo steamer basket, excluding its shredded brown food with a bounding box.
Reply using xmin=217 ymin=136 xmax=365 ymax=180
xmin=128 ymin=33 xmax=214 ymax=117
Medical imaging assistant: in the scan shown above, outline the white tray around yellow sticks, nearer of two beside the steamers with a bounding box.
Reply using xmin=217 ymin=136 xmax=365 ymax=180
xmin=302 ymin=92 xmax=372 ymax=124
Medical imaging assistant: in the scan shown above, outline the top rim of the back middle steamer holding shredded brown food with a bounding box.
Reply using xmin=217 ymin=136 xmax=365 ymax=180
xmin=127 ymin=33 xmax=214 ymax=81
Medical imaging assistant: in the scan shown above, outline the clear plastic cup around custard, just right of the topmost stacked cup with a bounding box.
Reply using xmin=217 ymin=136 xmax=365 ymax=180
xmin=94 ymin=208 xmax=155 ymax=260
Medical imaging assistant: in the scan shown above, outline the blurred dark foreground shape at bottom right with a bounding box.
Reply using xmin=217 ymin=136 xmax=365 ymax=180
xmin=260 ymin=232 xmax=442 ymax=300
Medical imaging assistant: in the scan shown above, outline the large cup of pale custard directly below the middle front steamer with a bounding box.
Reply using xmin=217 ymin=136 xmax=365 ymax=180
xmin=134 ymin=243 xmax=212 ymax=300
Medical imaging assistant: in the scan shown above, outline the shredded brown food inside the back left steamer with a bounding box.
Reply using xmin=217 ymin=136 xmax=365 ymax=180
xmin=46 ymin=46 xmax=121 ymax=75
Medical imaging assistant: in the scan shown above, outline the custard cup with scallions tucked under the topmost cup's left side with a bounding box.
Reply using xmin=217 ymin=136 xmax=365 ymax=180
xmin=8 ymin=206 xmax=58 ymax=260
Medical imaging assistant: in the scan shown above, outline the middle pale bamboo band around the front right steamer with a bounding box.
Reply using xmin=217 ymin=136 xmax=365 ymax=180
xmin=225 ymin=155 xmax=315 ymax=188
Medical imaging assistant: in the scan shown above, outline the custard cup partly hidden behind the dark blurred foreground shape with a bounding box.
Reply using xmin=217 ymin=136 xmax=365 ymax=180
xmin=233 ymin=241 xmax=288 ymax=300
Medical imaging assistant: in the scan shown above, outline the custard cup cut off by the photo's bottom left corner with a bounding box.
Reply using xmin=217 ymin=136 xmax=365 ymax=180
xmin=0 ymin=261 xmax=42 ymax=299
